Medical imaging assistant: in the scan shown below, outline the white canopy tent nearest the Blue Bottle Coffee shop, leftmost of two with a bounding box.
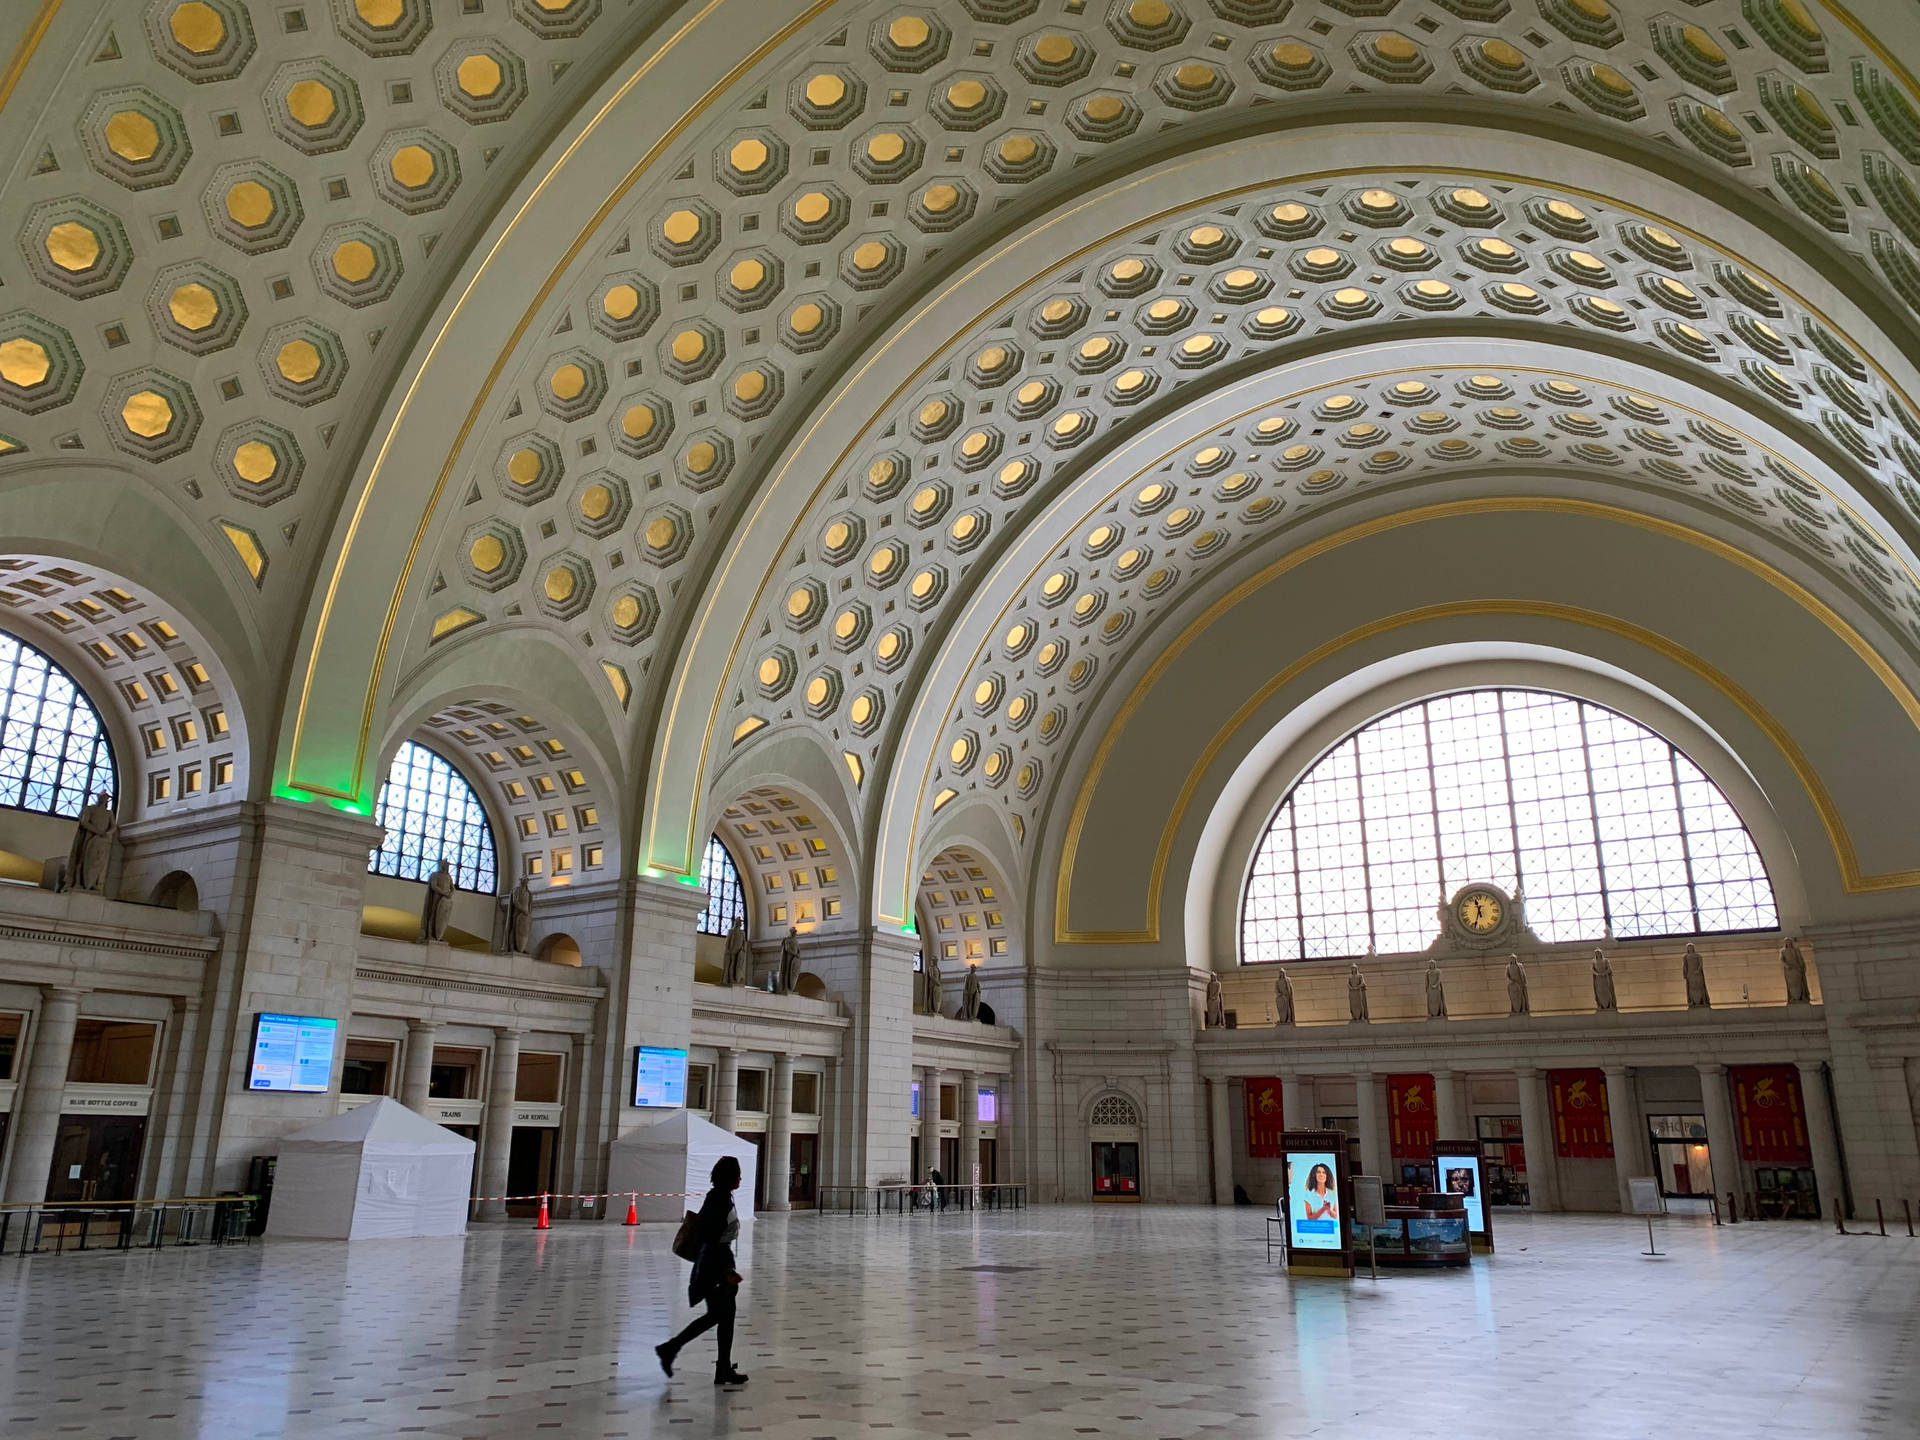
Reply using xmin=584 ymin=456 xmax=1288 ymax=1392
xmin=267 ymin=1096 xmax=474 ymax=1240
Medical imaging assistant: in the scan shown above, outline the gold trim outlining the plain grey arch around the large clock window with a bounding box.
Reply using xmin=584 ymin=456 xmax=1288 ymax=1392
xmin=1054 ymin=495 xmax=1920 ymax=945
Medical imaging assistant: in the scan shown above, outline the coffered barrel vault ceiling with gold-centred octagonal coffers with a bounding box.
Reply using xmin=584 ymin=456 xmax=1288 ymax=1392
xmin=0 ymin=0 xmax=1920 ymax=925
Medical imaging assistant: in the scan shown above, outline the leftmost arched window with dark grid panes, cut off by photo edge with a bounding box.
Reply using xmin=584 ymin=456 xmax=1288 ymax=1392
xmin=0 ymin=632 xmax=117 ymax=816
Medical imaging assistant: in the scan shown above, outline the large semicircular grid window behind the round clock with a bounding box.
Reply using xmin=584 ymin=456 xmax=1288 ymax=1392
xmin=1240 ymin=689 xmax=1778 ymax=964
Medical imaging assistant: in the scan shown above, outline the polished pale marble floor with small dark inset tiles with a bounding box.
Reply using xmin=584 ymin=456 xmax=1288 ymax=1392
xmin=0 ymin=1206 xmax=1920 ymax=1440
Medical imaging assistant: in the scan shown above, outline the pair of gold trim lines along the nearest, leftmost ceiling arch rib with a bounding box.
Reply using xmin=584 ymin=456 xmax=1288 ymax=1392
xmin=286 ymin=0 xmax=835 ymax=799
